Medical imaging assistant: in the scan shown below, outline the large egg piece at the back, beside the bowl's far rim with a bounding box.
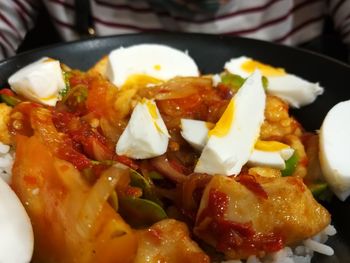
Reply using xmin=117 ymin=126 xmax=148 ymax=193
xmin=107 ymin=44 xmax=199 ymax=88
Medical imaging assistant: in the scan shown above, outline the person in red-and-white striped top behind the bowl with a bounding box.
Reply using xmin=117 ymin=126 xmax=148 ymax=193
xmin=0 ymin=0 xmax=350 ymax=60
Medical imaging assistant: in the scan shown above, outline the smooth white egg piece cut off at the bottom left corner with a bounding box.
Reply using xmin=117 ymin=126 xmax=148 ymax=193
xmin=0 ymin=178 xmax=34 ymax=263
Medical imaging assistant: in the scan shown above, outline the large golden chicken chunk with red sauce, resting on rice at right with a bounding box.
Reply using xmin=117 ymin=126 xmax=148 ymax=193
xmin=194 ymin=175 xmax=330 ymax=259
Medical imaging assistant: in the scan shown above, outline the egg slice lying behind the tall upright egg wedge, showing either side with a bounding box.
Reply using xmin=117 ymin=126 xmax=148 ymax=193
xmin=181 ymin=119 xmax=294 ymax=170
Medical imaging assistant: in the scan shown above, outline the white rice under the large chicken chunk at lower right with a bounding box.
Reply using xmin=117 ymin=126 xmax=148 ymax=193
xmin=221 ymin=225 xmax=337 ymax=263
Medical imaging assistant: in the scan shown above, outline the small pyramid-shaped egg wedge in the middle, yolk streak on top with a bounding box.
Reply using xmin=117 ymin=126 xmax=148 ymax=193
xmin=116 ymin=99 xmax=170 ymax=159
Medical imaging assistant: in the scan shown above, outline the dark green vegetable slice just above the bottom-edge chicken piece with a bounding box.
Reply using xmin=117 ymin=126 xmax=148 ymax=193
xmin=119 ymin=197 xmax=167 ymax=227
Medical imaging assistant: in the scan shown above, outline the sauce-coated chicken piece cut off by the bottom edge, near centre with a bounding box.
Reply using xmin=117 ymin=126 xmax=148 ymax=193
xmin=134 ymin=219 xmax=210 ymax=263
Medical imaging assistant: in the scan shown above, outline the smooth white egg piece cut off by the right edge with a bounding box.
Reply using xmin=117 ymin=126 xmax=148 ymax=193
xmin=319 ymin=100 xmax=350 ymax=201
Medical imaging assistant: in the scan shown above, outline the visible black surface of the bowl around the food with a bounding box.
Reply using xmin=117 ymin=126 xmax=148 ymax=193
xmin=0 ymin=34 xmax=350 ymax=263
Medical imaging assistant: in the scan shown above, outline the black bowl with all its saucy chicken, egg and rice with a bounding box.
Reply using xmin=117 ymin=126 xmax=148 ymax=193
xmin=0 ymin=34 xmax=350 ymax=263
